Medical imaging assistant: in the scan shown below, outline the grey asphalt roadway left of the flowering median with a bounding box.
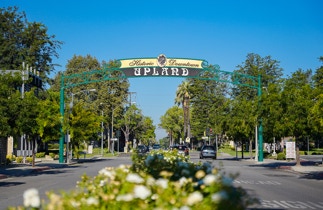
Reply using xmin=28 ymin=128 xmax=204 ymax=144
xmin=0 ymin=157 xmax=131 ymax=210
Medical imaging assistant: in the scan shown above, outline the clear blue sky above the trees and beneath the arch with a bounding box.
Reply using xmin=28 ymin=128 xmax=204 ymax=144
xmin=0 ymin=0 xmax=323 ymax=138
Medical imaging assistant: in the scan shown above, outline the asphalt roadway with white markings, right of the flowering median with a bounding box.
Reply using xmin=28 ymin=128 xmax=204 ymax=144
xmin=192 ymin=155 xmax=323 ymax=210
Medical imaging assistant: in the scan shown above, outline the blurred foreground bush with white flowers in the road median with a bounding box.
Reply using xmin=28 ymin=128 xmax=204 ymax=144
xmin=9 ymin=148 xmax=256 ymax=210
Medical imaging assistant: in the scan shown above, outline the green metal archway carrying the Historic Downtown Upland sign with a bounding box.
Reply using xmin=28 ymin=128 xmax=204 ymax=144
xmin=59 ymin=54 xmax=263 ymax=163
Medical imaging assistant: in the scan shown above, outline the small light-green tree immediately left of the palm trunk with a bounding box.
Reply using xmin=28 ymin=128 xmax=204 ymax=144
xmin=159 ymin=106 xmax=184 ymax=146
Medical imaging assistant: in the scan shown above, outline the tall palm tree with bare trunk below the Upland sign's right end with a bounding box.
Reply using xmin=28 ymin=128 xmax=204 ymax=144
xmin=175 ymin=81 xmax=191 ymax=144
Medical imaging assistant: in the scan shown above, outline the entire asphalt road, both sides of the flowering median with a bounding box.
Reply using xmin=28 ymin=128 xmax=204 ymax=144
xmin=0 ymin=152 xmax=323 ymax=210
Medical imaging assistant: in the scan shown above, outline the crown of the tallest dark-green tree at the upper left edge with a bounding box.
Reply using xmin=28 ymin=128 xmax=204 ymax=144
xmin=0 ymin=7 xmax=62 ymax=82
